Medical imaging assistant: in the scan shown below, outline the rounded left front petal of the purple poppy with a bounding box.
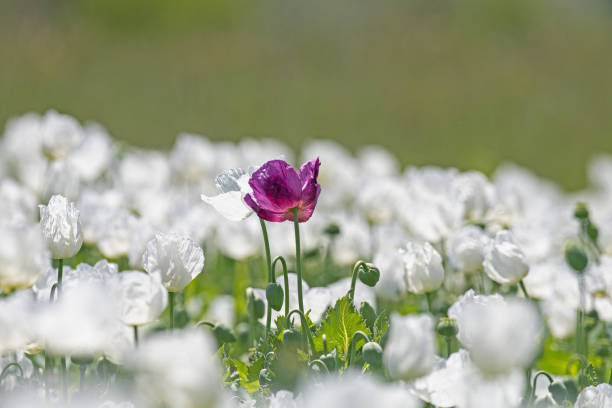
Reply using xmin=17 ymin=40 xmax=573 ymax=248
xmin=249 ymin=160 xmax=302 ymax=213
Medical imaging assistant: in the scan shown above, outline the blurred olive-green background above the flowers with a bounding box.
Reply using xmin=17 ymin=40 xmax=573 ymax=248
xmin=0 ymin=0 xmax=612 ymax=188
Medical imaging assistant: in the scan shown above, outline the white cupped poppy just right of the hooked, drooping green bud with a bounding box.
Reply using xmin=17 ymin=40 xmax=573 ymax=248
xmin=401 ymin=242 xmax=444 ymax=294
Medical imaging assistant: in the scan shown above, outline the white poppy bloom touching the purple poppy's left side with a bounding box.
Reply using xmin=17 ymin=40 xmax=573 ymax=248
xmin=200 ymin=168 xmax=255 ymax=221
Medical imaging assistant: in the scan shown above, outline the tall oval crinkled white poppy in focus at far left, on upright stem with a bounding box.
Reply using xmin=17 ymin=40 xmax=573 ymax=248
xmin=39 ymin=195 xmax=83 ymax=259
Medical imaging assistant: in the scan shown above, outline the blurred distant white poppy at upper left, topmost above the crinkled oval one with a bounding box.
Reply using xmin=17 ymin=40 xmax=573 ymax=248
xmin=40 ymin=110 xmax=84 ymax=160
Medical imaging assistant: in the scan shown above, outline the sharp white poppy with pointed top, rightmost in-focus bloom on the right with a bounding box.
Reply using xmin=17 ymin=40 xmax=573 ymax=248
xmin=484 ymin=230 xmax=529 ymax=285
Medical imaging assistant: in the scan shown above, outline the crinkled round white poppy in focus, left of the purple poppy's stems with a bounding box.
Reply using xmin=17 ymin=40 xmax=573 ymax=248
xmin=142 ymin=233 xmax=204 ymax=292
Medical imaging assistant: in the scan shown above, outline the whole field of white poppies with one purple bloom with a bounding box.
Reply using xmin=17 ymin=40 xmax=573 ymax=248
xmin=0 ymin=111 xmax=612 ymax=408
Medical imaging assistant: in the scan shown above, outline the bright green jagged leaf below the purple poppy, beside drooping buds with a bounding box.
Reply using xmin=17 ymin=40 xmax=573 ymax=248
xmin=314 ymin=296 xmax=370 ymax=356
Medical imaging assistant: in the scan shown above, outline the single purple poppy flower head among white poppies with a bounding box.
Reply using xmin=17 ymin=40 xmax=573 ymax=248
xmin=244 ymin=157 xmax=321 ymax=222
